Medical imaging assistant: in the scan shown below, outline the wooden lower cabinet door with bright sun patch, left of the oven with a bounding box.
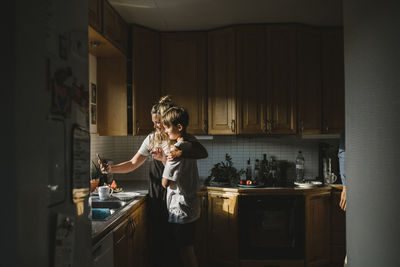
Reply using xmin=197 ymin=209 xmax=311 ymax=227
xmin=208 ymin=194 xmax=239 ymax=266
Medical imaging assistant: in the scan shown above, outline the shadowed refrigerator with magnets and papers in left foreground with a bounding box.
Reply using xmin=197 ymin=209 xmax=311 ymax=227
xmin=12 ymin=0 xmax=92 ymax=267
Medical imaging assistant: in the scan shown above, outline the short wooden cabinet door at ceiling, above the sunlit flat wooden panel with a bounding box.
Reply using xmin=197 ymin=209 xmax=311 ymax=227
xmin=103 ymin=1 xmax=128 ymax=53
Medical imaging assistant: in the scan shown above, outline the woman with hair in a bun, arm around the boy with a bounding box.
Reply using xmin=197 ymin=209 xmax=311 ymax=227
xmin=99 ymin=96 xmax=208 ymax=266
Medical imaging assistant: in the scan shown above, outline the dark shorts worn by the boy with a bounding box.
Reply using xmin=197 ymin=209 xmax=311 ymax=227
xmin=169 ymin=220 xmax=197 ymax=248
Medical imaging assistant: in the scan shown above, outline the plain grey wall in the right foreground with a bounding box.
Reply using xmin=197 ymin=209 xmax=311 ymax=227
xmin=343 ymin=0 xmax=400 ymax=267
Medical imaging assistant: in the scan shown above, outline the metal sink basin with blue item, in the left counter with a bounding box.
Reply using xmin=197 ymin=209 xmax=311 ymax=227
xmin=89 ymin=196 xmax=128 ymax=221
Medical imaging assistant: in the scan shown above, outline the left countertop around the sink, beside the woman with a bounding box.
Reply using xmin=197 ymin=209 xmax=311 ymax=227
xmin=92 ymin=181 xmax=149 ymax=244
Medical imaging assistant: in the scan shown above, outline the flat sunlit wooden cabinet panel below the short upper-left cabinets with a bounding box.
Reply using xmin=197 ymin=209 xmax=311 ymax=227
xmin=97 ymin=57 xmax=127 ymax=136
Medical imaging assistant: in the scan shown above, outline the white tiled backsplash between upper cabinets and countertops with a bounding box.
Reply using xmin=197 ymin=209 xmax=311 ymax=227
xmin=91 ymin=135 xmax=336 ymax=183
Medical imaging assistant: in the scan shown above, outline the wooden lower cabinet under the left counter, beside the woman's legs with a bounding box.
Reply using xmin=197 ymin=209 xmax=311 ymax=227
xmin=113 ymin=202 xmax=149 ymax=267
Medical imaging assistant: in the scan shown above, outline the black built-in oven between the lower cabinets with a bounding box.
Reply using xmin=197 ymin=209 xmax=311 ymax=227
xmin=239 ymin=195 xmax=305 ymax=260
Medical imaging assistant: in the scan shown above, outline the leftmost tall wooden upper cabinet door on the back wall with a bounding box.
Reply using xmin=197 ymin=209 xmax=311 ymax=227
xmin=132 ymin=25 xmax=161 ymax=135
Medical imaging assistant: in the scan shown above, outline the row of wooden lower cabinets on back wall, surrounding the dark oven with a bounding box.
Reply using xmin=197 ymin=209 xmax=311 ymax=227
xmin=202 ymin=188 xmax=334 ymax=267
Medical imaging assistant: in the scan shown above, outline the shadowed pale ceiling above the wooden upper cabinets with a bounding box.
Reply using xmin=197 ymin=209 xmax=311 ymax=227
xmin=109 ymin=0 xmax=342 ymax=31
